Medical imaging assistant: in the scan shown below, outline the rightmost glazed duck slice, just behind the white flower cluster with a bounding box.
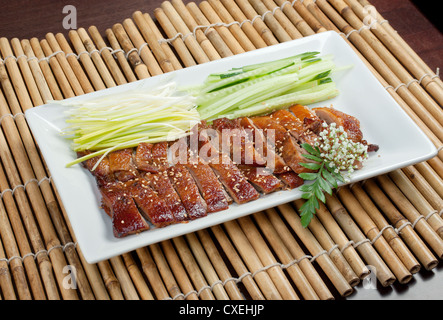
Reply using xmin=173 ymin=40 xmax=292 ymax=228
xmin=313 ymin=107 xmax=379 ymax=152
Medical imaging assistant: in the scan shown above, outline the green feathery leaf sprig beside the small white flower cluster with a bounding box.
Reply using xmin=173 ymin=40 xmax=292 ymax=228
xmin=299 ymin=143 xmax=345 ymax=227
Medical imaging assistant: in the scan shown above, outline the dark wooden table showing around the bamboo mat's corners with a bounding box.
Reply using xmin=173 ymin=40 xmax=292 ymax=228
xmin=0 ymin=0 xmax=443 ymax=300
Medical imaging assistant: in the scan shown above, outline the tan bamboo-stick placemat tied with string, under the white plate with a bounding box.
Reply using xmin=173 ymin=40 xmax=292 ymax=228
xmin=0 ymin=0 xmax=443 ymax=300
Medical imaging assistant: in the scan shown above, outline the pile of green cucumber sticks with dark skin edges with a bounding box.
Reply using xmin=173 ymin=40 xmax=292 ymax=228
xmin=184 ymin=52 xmax=338 ymax=121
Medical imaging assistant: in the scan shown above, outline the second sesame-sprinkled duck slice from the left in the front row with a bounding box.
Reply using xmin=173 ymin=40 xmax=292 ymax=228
xmin=128 ymin=179 xmax=175 ymax=228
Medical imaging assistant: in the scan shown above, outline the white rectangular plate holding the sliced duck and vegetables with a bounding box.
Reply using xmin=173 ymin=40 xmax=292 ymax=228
xmin=26 ymin=32 xmax=437 ymax=263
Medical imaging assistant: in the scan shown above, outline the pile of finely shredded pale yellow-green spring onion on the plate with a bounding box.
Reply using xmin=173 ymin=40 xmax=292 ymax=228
xmin=61 ymin=82 xmax=200 ymax=167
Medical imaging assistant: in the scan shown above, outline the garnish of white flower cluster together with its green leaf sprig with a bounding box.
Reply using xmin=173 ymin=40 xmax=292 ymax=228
xmin=299 ymin=123 xmax=368 ymax=227
